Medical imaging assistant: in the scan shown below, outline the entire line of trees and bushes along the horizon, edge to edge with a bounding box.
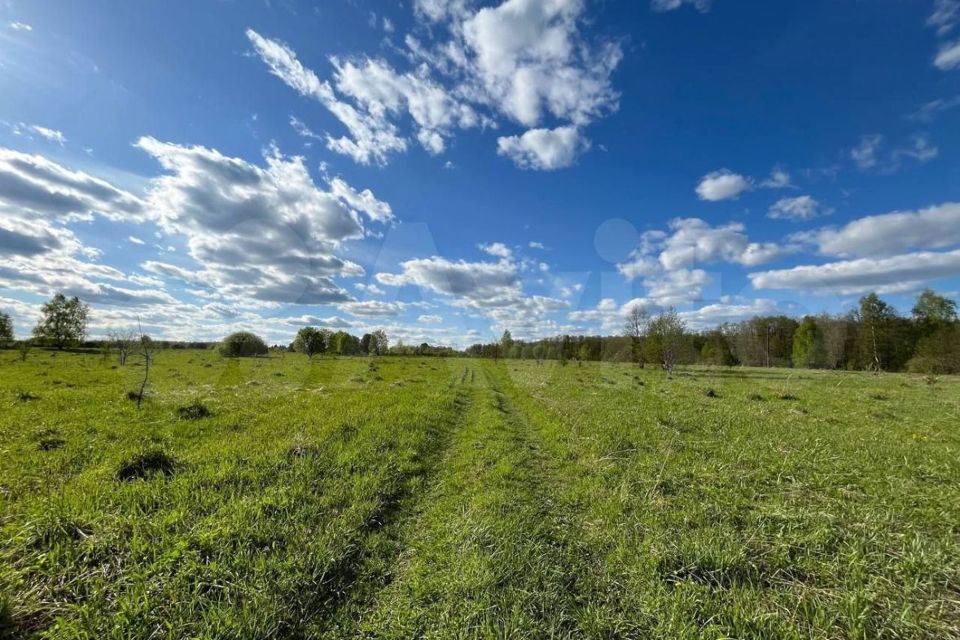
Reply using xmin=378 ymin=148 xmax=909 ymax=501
xmin=0 ymin=289 xmax=960 ymax=374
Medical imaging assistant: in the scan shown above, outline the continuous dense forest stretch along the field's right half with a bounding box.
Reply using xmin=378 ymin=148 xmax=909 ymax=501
xmin=467 ymin=289 xmax=960 ymax=374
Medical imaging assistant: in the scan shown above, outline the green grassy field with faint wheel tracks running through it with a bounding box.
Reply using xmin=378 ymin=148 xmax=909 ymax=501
xmin=0 ymin=351 xmax=960 ymax=640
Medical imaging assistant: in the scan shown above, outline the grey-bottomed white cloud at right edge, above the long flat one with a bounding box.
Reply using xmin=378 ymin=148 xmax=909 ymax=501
xmin=799 ymin=202 xmax=960 ymax=257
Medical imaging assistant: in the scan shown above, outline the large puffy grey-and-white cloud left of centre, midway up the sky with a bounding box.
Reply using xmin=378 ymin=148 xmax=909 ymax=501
xmin=137 ymin=138 xmax=389 ymax=304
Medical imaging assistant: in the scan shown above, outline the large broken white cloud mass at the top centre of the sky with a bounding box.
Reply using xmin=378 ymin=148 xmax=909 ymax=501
xmin=247 ymin=0 xmax=622 ymax=169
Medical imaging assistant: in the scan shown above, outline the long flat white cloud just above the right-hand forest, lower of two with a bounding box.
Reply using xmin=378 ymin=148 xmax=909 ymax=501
xmin=749 ymin=251 xmax=960 ymax=295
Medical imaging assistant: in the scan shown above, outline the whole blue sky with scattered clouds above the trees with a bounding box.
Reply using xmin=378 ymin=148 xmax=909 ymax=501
xmin=0 ymin=0 xmax=960 ymax=346
